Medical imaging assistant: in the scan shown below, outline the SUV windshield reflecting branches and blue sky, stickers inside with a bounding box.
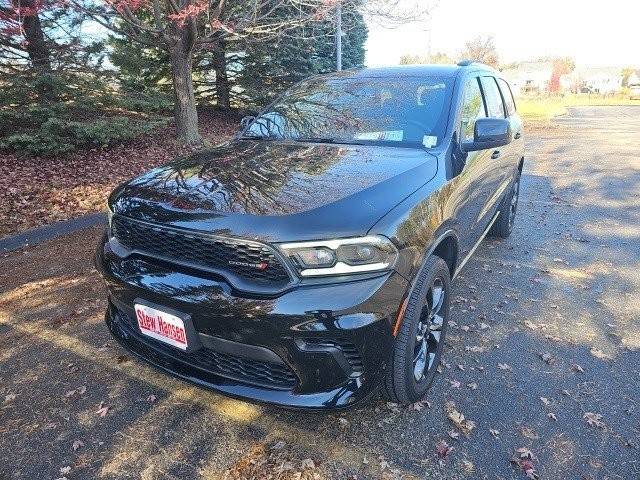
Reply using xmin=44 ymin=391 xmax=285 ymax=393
xmin=243 ymin=77 xmax=453 ymax=148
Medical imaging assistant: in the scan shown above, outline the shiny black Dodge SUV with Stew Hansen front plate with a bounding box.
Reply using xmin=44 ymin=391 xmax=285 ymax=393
xmin=96 ymin=63 xmax=524 ymax=408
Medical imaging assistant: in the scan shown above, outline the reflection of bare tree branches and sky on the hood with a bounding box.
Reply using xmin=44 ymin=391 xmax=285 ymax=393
xmin=118 ymin=141 xmax=427 ymax=215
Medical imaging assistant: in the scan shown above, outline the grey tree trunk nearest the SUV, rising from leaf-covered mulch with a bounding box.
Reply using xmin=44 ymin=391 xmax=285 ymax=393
xmin=169 ymin=41 xmax=202 ymax=145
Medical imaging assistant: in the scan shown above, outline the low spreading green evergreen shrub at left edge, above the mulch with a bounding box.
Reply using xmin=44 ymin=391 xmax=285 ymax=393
xmin=0 ymin=74 xmax=171 ymax=155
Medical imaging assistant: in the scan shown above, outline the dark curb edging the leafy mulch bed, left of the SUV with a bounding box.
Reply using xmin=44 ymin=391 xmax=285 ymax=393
xmin=0 ymin=213 xmax=107 ymax=253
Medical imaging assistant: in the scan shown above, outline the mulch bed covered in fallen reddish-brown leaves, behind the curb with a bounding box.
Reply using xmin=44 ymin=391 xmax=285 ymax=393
xmin=0 ymin=110 xmax=239 ymax=238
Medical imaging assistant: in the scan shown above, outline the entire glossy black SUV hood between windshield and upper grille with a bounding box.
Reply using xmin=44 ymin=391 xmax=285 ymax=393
xmin=110 ymin=140 xmax=437 ymax=241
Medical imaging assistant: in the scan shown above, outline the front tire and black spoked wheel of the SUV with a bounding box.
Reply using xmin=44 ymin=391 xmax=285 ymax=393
xmin=384 ymin=255 xmax=451 ymax=405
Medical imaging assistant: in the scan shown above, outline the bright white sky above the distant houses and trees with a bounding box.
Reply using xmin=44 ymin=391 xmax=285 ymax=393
xmin=366 ymin=0 xmax=640 ymax=68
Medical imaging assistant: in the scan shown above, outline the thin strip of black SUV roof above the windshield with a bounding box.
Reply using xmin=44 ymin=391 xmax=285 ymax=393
xmin=318 ymin=62 xmax=497 ymax=79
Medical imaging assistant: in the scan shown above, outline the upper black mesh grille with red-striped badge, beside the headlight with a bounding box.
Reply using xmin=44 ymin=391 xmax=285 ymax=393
xmin=111 ymin=215 xmax=290 ymax=286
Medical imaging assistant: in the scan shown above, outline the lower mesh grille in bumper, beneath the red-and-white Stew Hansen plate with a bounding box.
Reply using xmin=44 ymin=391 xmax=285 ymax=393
xmin=118 ymin=313 xmax=297 ymax=390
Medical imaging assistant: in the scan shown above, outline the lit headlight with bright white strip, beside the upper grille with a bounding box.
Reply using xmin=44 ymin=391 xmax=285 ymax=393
xmin=279 ymin=235 xmax=398 ymax=277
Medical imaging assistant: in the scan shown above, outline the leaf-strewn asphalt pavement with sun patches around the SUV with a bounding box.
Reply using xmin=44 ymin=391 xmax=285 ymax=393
xmin=0 ymin=107 xmax=640 ymax=480
